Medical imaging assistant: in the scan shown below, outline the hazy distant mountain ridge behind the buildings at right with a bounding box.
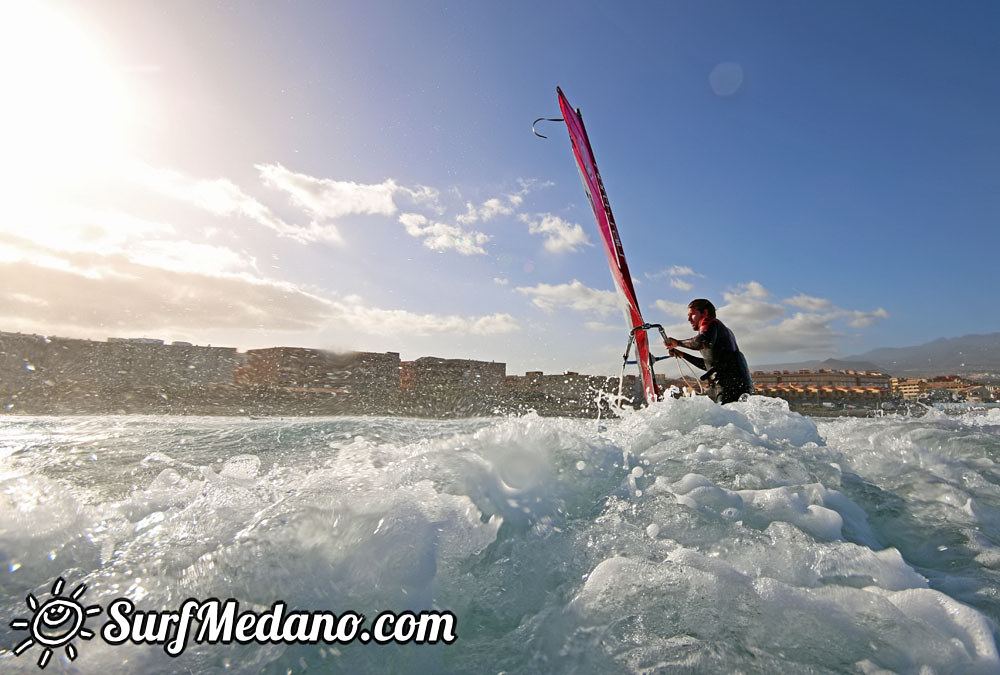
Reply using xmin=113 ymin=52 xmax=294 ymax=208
xmin=753 ymin=333 xmax=1000 ymax=377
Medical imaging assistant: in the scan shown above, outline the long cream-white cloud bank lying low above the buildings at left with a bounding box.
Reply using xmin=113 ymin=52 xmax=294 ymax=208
xmin=0 ymin=228 xmax=520 ymax=344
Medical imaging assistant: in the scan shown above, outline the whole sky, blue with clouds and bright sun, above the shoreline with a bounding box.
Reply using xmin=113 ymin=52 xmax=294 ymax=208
xmin=0 ymin=0 xmax=1000 ymax=374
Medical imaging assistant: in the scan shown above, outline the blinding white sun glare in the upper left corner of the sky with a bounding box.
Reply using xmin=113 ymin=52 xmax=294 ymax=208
xmin=0 ymin=1 xmax=132 ymax=199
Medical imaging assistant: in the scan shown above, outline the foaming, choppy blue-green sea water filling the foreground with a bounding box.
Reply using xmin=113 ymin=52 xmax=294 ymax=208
xmin=0 ymin=397 xmax=1000 ymax=674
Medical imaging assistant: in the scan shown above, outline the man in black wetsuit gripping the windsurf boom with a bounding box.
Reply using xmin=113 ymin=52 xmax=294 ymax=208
xmin=664 ymin=298 xmax=753 ymax=404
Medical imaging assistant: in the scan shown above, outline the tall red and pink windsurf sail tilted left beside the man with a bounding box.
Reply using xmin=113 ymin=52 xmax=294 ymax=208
xmin=556 ymin=87 xmax=663 ymax=404
